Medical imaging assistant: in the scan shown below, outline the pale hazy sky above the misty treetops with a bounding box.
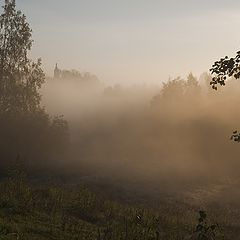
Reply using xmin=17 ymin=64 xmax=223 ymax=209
xmin=16 ymin=0 xmax=240 ymax=83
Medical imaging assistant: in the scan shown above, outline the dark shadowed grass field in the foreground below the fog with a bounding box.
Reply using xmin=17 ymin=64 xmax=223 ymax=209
xmin=0 ymin=167 xmax=240 ymax=240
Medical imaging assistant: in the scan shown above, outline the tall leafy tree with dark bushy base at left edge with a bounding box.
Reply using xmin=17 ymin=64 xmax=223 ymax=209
xmin=0 ymin=0 xmax=68 ymax=167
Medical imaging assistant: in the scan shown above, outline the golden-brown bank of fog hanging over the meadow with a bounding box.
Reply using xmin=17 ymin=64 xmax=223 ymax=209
xmin=38 ymin=71 xmax=240 ymax=199
